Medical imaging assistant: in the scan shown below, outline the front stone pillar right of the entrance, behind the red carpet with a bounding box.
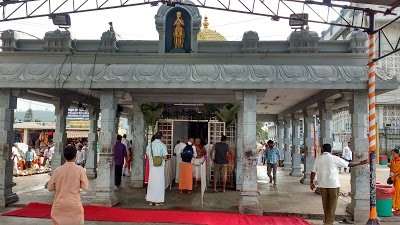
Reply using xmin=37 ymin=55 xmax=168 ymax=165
xmin=239 ymin=91 xmax=263 ymax=215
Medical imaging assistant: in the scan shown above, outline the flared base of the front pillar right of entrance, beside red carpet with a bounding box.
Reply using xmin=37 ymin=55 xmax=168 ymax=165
xmin=239 ymin=192 xmax=263 ymax=215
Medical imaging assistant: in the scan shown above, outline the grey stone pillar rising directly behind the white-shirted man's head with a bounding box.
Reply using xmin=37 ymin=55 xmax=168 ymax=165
xmin=318 ymin=101 xmax=334 ymax=146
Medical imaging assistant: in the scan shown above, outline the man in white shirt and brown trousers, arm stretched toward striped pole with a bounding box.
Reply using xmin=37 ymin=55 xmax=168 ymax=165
xmin=310 ymin=144 xmax=368 ymax=225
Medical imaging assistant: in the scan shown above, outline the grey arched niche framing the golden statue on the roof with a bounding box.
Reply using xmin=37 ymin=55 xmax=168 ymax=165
xmin=155 ymin=0 xmax=201 ymax=53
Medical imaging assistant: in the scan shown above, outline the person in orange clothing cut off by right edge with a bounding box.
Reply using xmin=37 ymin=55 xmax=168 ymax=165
xmin=390 ymin=147 xmax=400 ymax=216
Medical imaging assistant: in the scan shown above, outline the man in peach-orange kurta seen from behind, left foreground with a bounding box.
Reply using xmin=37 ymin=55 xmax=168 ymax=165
xmin=47 ymin=145 xmax=89 ymax=225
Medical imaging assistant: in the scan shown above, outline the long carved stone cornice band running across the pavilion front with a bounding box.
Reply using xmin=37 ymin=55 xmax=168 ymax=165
xmin=0 ymin=63 xmax=390 ymax=83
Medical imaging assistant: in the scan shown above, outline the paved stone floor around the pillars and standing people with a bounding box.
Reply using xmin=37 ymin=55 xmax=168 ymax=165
xmin=0 ymin=164 xmax=400 ymax=225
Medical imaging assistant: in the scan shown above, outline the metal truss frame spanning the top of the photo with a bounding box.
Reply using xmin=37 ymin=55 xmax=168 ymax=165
xmin=0 ymin=0 xmax=400 ymax=61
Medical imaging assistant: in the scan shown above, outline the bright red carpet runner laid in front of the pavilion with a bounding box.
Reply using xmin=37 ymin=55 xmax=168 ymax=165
xmin=3 ymin=203 xmax=310 ymax=225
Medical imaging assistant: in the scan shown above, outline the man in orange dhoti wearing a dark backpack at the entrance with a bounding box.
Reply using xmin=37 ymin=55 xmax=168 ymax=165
xmin=177 ymin=138 xmax=196 ymax=193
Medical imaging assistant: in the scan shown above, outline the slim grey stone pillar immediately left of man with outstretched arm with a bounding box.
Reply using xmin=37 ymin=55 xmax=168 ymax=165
xmin=300 ymin=109 xmax=315 ymax=184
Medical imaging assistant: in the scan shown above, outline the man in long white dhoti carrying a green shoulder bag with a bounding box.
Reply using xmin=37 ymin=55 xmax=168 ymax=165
xmin=146 ymin=132 xmax=168 ymax=206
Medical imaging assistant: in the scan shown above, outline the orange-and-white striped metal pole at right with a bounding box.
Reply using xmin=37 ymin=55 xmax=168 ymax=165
xmin=367 ymin=12 xmax=379 ymax=225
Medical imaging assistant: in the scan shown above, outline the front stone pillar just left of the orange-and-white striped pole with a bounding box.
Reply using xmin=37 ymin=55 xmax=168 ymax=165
xmin=349 ymin=91 xmax=370 ymax=224
